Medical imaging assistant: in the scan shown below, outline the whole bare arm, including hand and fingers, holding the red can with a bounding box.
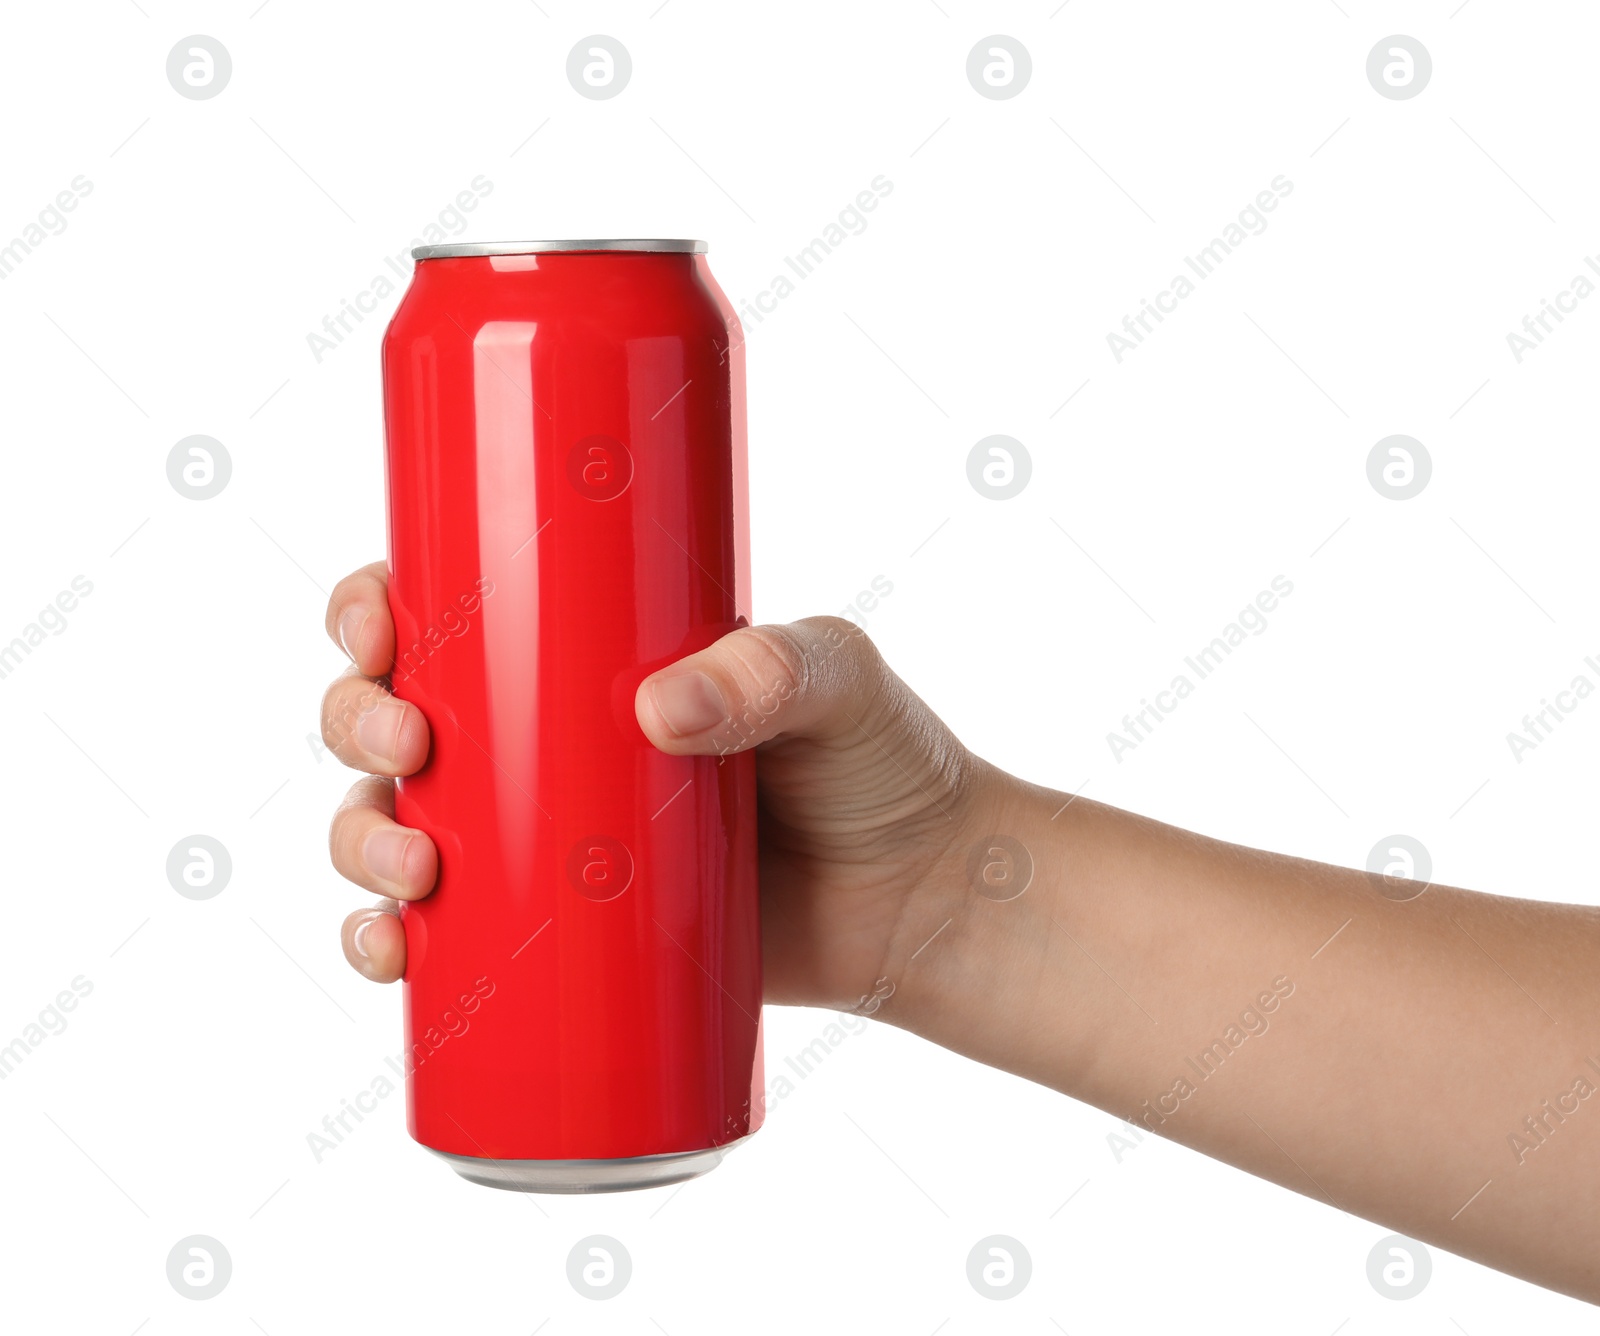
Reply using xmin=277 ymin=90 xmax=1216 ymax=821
xmin=323 ymin=562 xmax=1600 ymax=1302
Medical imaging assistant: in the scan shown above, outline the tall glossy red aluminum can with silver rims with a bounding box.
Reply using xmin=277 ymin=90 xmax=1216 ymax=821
xmin=382 ymin=240 xmax=763 ymax=1192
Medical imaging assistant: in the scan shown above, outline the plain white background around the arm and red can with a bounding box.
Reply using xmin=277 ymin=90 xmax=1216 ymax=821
xmin=0 ymin=0 xmax=1600 ymax=1336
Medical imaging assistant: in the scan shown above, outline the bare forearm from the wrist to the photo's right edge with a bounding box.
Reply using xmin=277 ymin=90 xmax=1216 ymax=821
xmin=883 ymin=778 xmax=1600 ymax=1299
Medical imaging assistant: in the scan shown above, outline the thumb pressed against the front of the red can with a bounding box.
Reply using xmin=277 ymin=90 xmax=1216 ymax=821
xmin=634 ymin=618 xmax=891 ymax=755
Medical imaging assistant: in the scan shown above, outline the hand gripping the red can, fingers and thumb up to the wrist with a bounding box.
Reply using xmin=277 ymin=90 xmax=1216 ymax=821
xmin=322 ymin=562 xmax=997 ymax=1011
